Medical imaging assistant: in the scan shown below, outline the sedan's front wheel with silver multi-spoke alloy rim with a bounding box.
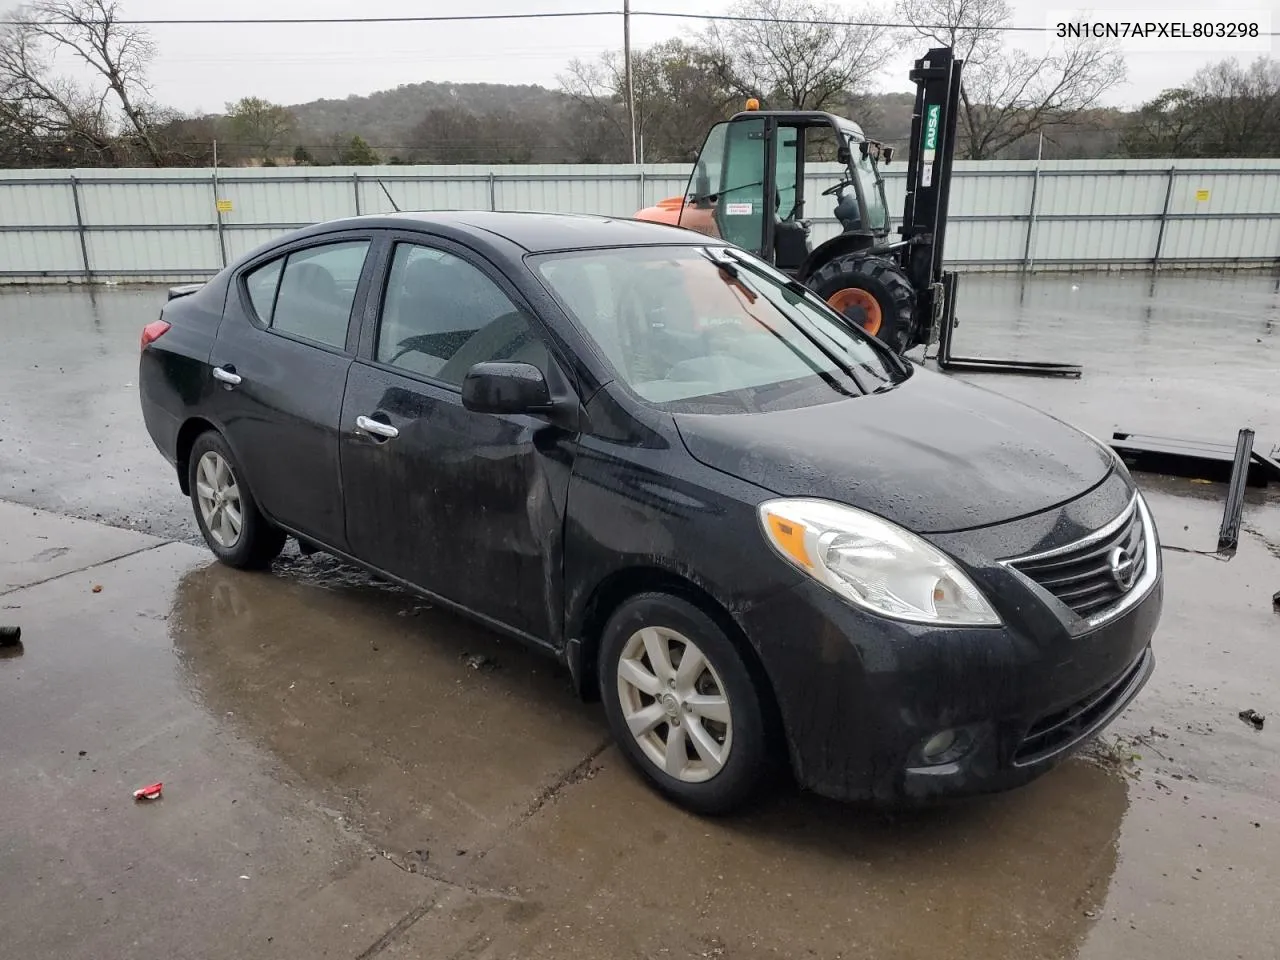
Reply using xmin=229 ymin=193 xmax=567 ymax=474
xmin=599 ymin=593 xmax=772 ymax=814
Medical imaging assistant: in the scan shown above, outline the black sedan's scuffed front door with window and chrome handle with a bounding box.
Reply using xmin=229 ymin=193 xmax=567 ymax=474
xmin=342 ymin=239 xmax=572 ymax=643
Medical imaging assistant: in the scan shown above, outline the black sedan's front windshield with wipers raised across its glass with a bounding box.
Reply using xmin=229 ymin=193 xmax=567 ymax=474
xmin=535 ymin=246 xmax=910 ymax=412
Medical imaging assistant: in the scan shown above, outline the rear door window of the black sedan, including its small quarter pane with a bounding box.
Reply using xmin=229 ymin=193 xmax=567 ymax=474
xmin=244 ymin=241 xmax=369 ymax=349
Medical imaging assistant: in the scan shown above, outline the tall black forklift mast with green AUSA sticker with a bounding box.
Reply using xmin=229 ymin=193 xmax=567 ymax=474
xmin=900 ymin=47 xmax=964 ymax=343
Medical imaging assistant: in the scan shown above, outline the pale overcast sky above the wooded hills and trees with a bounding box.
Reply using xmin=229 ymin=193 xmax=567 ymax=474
xmin=35 ymin=0 xmax=1280 ymax=113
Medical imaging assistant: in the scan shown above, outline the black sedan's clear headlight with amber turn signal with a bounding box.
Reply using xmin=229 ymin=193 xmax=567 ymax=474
xmin=759 ymin=499 xmax=1000 ymax=626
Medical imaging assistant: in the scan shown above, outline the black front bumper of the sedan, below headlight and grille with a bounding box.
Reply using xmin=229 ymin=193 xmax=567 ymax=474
xmin=744 ymin=555 xmax=1164 ymax=803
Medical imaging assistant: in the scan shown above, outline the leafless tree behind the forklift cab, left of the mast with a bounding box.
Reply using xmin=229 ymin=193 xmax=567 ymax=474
xmin=704 ymin=0 xmax=893 ymax=110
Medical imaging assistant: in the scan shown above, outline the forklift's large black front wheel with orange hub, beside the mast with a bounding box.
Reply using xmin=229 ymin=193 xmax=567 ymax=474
xmin=806 ymin=253 xmax=915 ymax=353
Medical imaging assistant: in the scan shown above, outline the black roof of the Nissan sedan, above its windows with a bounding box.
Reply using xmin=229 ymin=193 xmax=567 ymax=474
xmin=314 ymin=210 xmax=708 ymax=253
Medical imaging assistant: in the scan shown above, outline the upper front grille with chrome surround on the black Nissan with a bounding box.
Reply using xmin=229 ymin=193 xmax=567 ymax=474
xmin=1009 ymin=498 xmax=1147 ymax=617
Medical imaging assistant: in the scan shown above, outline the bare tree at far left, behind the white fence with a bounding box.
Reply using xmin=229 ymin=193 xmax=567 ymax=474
xmin=0 ymin=0 xmax=168 ymax=166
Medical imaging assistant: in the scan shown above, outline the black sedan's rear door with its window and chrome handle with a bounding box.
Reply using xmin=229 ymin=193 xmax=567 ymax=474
xmin=210 ymin=233 xmax=374 ymax=549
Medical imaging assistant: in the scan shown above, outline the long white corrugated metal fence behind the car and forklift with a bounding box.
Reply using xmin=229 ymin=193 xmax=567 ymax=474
xmin=0 ymin=160 xmax=1280 ymax=283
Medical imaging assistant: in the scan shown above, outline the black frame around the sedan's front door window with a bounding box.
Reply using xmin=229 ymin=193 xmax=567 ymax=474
xmin=356 ymin=232 xmax=564 ymax=399
